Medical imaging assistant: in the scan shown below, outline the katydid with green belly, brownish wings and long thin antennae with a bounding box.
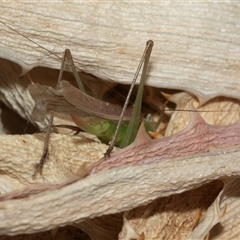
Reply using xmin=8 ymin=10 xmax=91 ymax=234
xmin=0 ymin=21 xmax=235 ymax=178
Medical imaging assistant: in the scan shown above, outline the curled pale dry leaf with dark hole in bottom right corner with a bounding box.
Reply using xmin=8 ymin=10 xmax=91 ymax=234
xmin=188 ymin=178 xmax=240 ymax=239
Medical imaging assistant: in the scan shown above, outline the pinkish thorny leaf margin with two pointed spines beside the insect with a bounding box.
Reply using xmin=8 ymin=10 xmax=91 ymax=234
xmin=89 ymin=112 xmax=240 ymax=174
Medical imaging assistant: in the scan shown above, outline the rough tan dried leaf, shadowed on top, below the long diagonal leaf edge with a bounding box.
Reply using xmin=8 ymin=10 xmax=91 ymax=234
xmin=120 ymin=181 xmax=222 ymax=240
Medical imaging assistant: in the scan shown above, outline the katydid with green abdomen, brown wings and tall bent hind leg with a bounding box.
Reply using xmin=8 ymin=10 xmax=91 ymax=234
xmin=29 ymin=40 xmax=153 ymax=175
